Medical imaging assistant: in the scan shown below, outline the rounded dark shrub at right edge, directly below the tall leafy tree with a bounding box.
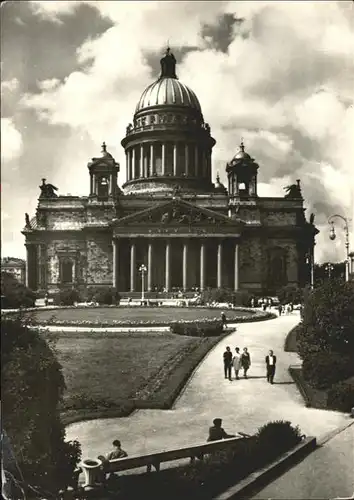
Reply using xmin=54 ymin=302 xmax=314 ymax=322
xmin=302 ymin=351 xmax=354 ymax=389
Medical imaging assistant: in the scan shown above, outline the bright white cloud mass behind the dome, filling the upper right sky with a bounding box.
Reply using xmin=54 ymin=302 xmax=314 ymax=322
xmin=22 ymin=1 xmax=354 ymax=260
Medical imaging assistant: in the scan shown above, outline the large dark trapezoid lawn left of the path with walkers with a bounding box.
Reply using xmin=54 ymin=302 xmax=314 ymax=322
xmin=51 ymin=332 xmax=224 ymax=423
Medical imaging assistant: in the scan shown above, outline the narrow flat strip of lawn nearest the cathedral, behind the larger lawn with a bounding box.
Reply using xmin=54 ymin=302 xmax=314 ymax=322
xmin=30 ymin=307 xmax=255 ymax=324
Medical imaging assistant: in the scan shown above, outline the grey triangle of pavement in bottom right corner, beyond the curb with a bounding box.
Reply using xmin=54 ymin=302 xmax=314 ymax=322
xmin=253 ymin=422 xmax=354 ymax=500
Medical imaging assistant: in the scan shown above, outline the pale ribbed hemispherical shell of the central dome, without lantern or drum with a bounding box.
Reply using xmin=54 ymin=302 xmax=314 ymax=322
xmin=135 ymin=77 xmax=201 ymax=113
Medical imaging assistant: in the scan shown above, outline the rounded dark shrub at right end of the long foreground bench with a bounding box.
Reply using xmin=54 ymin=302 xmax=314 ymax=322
xmin=256 ymin=420 xmax=302 ymax=460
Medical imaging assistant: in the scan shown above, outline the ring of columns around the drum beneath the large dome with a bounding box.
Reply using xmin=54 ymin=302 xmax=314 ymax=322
xmin=125 ymin=142 xmax=211 ymax=181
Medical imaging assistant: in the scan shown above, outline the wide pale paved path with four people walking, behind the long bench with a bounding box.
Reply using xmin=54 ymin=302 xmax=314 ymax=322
xmin=67 ymin=313 xmax=349 ymax=457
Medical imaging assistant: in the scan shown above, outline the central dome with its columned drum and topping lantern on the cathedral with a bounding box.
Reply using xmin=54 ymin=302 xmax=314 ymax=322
xmin=122 ymin=49 xmax=215 ymax=193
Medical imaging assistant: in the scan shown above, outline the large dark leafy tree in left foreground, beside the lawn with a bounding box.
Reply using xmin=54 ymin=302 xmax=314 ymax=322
xmin=1 ymin=317 xmax=81 ymax=494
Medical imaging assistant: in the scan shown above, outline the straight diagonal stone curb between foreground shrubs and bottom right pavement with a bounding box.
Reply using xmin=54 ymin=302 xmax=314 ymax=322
xmin=213 ymin=437 xmax=317 ymax=500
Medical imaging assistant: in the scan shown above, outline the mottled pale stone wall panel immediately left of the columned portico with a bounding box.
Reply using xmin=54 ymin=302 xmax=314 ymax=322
xmin=87 ymin=234 xmax=113 ymax=286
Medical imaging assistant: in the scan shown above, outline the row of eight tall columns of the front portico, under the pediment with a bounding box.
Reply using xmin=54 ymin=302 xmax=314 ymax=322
xmin=113 ymin=240 xmax=239 ymax=292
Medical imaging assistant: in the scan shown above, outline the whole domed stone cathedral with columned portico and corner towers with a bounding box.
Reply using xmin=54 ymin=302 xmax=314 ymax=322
xmin=22 ymin=49 xmax=318 ymax=296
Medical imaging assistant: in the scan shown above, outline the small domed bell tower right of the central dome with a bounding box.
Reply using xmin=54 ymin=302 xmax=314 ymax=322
xmin=226 ymin=142 xmax=259 ymax=199
